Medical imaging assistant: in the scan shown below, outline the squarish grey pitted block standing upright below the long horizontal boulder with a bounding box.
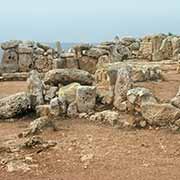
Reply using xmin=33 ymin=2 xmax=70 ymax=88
xmin=76 ymin=86 xmax=96 ymax=112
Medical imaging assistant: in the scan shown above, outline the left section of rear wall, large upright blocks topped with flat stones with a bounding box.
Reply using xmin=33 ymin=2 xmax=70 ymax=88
xmin=1 ymin=41 xmax=59 ymax=73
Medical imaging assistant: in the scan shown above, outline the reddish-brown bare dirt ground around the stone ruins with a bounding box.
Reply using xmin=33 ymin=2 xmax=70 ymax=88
xmin=0 ymin=72 xmax=180 ymax=180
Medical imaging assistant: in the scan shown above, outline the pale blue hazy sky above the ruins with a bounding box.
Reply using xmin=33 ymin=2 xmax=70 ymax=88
xmin=0 ymin=0 xmax=180 ymax=42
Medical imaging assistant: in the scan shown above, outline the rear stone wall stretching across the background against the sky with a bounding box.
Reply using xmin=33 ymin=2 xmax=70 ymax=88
xmin=0 ymin=34 xmax=180 ymax=74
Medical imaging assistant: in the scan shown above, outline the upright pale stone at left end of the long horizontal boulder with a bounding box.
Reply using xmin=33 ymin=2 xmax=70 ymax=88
xmin=27 ymin=70 xmax=44 ymax=108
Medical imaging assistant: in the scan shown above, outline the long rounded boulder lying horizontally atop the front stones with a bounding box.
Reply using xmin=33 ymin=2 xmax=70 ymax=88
xmin=44 ymin=69 xmax=93 ymax=85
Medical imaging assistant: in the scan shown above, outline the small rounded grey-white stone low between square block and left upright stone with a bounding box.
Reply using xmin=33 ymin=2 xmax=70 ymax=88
xmin=50 ymin=97 xmax=67 ymax=117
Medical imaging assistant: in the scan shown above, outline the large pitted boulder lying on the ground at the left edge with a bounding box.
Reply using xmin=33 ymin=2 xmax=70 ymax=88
xmin=0 ymin=92 xmax=31 ymax=119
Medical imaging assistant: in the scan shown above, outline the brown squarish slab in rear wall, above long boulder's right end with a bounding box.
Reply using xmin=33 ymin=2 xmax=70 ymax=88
xmin=79 ymin=56 xmax=98 ymax=74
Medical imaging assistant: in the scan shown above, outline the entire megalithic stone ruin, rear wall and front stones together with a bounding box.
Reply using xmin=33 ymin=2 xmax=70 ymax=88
xmin=0 ymin=34 xmax=180 ymax=130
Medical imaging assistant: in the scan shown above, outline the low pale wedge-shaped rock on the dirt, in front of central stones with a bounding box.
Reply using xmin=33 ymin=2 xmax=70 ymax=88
xmin=90 ymin=110 xmax=119 ymax=126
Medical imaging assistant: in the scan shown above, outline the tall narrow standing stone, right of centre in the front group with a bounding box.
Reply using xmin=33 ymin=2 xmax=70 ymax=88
xmin=113 ymin=67 xmax=133 ymax=109
